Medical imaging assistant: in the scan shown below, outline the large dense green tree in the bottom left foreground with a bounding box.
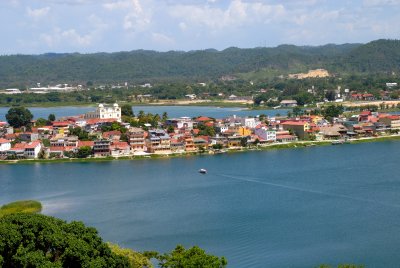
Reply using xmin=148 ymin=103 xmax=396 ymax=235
xmin=0 ymin=213 xmax=129 ymax=267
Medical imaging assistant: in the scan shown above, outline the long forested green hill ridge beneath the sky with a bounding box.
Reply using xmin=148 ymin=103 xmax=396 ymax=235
xmin=0 ymin=40 xmax=400 ymax=87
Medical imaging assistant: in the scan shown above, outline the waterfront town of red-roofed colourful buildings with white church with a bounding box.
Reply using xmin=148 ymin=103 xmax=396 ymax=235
xmin=0 ymin=102 xmax=400 ymax=162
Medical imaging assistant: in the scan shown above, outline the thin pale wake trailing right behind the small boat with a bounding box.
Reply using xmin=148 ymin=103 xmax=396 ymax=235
xmin=215 ymin=174 xmax=400 ymax=208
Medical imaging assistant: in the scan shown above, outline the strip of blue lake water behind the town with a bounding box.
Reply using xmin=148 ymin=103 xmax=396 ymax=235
xmin=0 ymin=106 xmax=288 ymax=120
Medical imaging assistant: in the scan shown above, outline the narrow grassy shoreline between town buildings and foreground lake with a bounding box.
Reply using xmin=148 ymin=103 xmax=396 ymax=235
xmin=0 ymin=134 xmax=400 ymax=165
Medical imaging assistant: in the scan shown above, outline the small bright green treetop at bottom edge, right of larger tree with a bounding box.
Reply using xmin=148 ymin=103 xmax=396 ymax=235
xmin=157 ymin=245 xmax=228 ymax=268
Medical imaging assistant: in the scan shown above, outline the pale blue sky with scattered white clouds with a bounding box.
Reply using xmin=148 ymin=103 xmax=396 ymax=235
xmin=0 ymin=0 xmax=400 ymax=55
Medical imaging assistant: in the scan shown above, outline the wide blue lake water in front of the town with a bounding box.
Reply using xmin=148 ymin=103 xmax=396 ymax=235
xmin=0 ymin=141 xmax=400 ymax=267
